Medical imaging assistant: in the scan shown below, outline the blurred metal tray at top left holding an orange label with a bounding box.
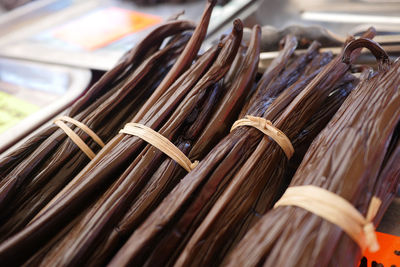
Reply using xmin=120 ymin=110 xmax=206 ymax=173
xmin=0 ymin=0 xmax=254 ymax=70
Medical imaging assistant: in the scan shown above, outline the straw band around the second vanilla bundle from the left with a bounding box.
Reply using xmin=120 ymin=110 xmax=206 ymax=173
xmin=119 ymin=122 xmax=199 ymax=172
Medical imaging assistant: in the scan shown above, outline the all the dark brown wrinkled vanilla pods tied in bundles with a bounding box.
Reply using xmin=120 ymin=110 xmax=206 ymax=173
xmin=0 ymin=0 xmax=400 ymax=266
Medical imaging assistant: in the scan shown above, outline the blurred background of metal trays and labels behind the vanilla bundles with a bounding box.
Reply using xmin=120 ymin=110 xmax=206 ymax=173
xmin=0 ymin=0 xmax=400 ymax=153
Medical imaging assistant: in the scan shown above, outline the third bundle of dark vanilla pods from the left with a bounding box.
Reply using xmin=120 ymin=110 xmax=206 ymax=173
xmin=105 ymin=29 xmax=375 ymax=266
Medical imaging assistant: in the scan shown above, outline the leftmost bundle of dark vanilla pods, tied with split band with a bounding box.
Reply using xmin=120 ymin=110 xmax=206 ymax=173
xmin=0 ymin=21 xmax=193 ymax=241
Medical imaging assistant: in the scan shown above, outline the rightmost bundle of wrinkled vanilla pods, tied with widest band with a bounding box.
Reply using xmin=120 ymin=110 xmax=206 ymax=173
xmin=225 ymin=37 xmax=400 ymax=266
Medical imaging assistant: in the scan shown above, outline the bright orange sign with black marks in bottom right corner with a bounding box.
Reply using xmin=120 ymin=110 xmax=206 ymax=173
xmin=364 ymin=232 xmax=400 ymax=267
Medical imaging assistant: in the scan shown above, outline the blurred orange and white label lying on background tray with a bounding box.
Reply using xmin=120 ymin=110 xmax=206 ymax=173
xmin=53 ymin=7 xmax=162 ymax=50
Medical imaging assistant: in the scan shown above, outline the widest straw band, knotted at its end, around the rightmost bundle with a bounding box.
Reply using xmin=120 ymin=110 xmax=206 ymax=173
xmin=274 ymin=185 xmax=381 ymax=252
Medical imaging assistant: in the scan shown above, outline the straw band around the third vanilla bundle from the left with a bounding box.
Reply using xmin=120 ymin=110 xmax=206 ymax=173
xmin=231 ymin=115 xmax=294 ymax=159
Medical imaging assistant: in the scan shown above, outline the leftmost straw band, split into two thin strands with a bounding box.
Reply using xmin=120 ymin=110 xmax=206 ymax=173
xmin=54 ymin=116 xmax=104 ymax=159
